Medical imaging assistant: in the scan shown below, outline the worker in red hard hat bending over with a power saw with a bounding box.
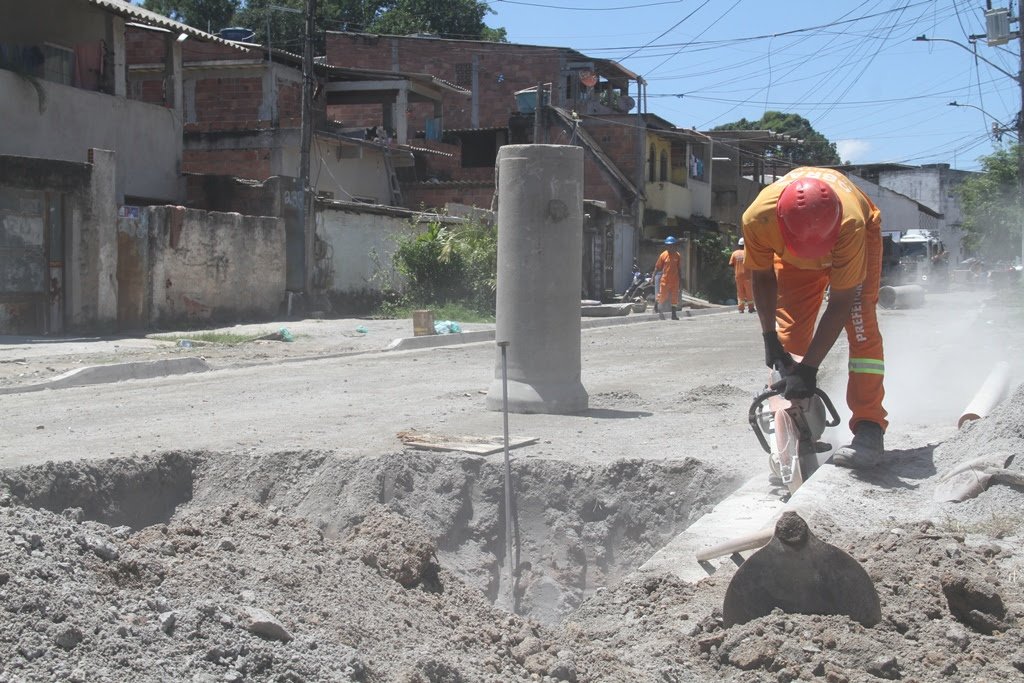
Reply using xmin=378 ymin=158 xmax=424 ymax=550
xmin=742 ymin=167 xmax=888 ymax=468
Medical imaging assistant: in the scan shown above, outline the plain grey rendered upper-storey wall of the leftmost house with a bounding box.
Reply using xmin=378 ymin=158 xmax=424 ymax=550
xmin=0 ymin=70 xmax=181 ymax=202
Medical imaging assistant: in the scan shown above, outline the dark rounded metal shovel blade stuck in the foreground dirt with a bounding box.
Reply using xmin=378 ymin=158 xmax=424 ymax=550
xmin=722 ymin=512 xmax=882 ymax=626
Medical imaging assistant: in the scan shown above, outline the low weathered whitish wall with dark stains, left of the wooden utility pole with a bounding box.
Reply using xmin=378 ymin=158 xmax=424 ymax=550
xmin=118 ymin=206 xmax=286 ymax=328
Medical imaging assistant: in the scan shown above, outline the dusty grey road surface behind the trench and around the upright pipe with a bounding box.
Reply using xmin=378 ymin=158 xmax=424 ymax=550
xmin=0 ymin=294 xmax=1024 ymax=481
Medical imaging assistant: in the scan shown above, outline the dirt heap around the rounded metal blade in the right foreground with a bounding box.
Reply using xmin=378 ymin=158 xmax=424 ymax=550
xmin=565 ymin=522 xmax=1024 ymax=682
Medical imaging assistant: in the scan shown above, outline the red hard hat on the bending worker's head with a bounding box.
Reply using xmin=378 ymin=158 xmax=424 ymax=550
xmin=775 ymin=178 xmax=843 ymax=258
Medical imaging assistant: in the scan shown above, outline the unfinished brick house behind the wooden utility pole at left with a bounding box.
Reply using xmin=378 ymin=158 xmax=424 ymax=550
xmin=127 ymin=30 xmax=469 ymax=206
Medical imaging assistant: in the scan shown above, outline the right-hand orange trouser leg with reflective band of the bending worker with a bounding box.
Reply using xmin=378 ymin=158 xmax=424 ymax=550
xmin=846 ymin=230 xmax=889 ymax=431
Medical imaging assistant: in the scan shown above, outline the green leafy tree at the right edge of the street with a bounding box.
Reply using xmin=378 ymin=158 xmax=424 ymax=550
xmin=954 ymin=145 xmax=1024 ymax=261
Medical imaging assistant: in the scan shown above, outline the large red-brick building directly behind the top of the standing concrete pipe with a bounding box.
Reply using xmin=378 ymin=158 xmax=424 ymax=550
xmin=327 ymin=32 xmax=643 ymax=215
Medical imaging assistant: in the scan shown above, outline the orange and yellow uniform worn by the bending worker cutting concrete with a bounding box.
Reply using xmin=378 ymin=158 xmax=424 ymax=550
xmin=743 ymin=167 xmax=889 ymax=430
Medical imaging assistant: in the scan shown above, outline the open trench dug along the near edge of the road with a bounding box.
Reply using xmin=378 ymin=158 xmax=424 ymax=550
xmin=0 ymin=451 xmax=738 ymax=625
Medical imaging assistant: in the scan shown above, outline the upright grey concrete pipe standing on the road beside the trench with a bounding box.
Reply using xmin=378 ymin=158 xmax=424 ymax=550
xmin=486 ymin=144 xmax=588 ymax=414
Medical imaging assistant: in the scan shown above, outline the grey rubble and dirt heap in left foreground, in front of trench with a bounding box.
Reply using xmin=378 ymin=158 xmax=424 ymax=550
xmin=0 ymin=503 xmax=593 ymax=683
